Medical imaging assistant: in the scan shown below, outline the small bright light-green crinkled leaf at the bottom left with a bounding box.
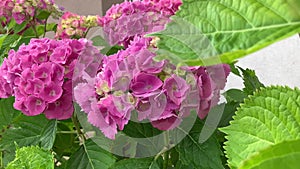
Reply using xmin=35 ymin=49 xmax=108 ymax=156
xmin=6 ymin=146 xmax=54 ymax=169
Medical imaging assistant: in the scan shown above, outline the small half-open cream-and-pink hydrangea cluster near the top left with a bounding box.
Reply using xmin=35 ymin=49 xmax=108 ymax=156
xmin=56 ymin=12 xmax=102 ymax=39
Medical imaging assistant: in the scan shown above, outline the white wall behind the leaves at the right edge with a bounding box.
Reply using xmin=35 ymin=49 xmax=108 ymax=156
xmin=227 ymin=35 xmax=300 ymax=88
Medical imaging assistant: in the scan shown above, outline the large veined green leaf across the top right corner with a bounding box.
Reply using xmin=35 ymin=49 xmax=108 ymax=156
xmin=152 ymin=0 xmax=300 ymax=65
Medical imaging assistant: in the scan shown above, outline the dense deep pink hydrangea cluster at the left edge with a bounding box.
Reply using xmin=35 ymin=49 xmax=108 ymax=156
xmin=0 ymin=38 xmax=99 ymax=119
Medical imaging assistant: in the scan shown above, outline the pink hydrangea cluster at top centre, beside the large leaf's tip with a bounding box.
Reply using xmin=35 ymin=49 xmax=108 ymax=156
xmin=101 ymin=0 xmax=182 ymax=47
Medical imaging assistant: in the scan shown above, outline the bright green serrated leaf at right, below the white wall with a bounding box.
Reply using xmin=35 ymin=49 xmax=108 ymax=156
xmin=221 ymin=87 xmax=300 ymax=168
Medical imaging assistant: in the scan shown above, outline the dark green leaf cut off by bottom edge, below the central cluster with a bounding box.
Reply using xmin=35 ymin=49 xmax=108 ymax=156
xmin=110 ymin=158 xmax=160 ymax=169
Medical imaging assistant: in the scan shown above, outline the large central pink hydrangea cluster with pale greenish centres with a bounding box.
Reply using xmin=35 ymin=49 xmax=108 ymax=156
xmin=74 ymin=36 xmax=230 ymax=139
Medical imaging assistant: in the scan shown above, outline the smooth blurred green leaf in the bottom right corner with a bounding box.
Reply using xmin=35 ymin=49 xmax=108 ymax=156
xmin=240 ymin=140 xmax=300 ymax=169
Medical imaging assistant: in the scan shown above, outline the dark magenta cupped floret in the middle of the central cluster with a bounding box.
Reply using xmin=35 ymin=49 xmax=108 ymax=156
xmin=130 ymin=73 xmax=163 ymax=97
